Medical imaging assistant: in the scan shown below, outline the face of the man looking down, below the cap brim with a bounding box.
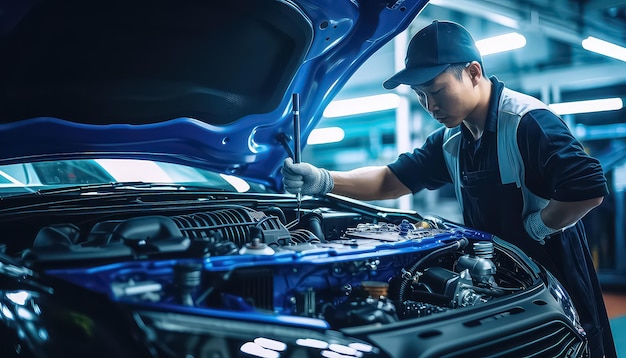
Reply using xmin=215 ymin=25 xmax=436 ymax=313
xmin=411 ymin=67 xmax=478 ymax=128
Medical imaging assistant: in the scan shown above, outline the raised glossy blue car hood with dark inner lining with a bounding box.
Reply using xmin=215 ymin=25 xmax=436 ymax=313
xmin=0 ymin=0 xmax=427 ymax=190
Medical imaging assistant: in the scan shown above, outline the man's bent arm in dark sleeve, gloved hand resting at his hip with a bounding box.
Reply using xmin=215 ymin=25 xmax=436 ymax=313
xmin=518 ymin=110 xmax=608 ymax=242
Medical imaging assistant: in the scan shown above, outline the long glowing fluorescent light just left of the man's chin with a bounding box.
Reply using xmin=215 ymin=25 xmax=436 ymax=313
xmin=324 ymin=93 xmax=400 ymax=118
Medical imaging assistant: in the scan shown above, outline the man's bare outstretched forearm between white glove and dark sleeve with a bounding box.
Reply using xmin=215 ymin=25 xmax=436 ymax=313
xmin=330 ymin=166 xmax=411 ymax=200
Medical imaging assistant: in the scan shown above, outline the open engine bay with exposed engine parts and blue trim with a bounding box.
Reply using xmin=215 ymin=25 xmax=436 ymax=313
xmin=2 ymin=199 xmax=534 ymax=329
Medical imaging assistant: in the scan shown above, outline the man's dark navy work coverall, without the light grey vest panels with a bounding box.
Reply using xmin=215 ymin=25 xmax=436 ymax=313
xmin=389 ymin=77 xmax=617 ymax=357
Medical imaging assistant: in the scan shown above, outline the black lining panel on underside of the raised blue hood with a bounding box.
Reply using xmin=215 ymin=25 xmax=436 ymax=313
xmin=2 ymin=0 xmax=313 ymax=125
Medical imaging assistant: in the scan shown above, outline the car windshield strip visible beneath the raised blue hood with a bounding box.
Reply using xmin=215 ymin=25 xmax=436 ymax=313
xmin=0 ymin=159 xmax=268 ymax=197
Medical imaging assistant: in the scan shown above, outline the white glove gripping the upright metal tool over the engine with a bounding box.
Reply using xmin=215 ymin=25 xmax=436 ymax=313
xmin=281 ymin=158 xmax=334 ymax=195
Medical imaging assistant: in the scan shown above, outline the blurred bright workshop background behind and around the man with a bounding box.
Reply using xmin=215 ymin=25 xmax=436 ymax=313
xmin=302 ymin=0 xmax=626 ymax=287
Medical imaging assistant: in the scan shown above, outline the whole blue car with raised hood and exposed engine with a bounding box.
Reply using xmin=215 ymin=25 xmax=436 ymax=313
xmin=0 ymin=0 xmax=587 ymax=357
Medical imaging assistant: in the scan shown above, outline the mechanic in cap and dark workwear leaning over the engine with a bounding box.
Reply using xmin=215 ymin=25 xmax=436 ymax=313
xmin=282 ymin=21 xmax=616 ymax=357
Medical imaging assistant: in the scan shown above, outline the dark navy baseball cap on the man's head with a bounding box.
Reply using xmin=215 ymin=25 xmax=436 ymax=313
xmin=383 ymin=20 xmax=482 ymax=89
